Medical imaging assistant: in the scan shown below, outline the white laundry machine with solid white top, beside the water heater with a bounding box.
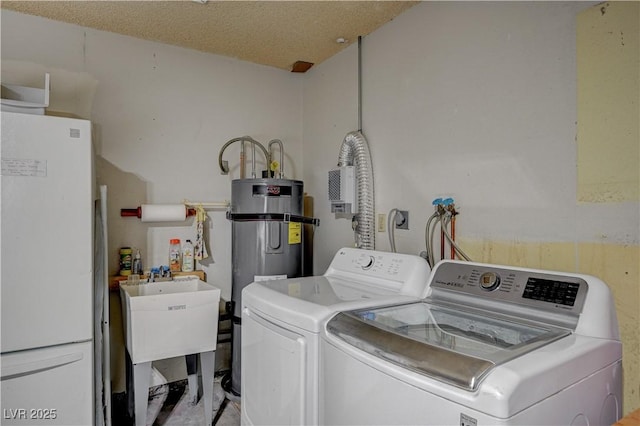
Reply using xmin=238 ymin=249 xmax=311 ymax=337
xmin=241 ymin=248 xmax=430 ymax=425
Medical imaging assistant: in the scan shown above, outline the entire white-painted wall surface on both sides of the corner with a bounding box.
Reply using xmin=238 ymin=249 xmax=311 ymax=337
xmin=2 ymin=2 xmax=639 ymax=298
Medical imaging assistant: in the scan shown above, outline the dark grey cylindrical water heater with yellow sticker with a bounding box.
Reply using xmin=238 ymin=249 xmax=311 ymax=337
xmin=228 ymin=178 xmax=315 ymax=395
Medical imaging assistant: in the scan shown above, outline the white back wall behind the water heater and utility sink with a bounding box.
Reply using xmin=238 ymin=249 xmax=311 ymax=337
xmin=2 ymin=10 xmax=302 ymax=300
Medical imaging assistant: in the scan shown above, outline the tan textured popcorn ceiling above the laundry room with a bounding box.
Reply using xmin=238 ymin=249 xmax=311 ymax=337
xmin=0 ymin=0 xmax=419 ymax=70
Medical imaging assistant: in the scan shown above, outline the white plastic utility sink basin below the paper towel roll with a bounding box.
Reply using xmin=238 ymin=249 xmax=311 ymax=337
xmin=120 ymin=276 xmax=220 ymax=364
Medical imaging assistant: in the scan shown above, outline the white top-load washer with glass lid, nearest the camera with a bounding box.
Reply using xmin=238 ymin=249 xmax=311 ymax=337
xmin=320 ymin=261 xmax=622 ymax=426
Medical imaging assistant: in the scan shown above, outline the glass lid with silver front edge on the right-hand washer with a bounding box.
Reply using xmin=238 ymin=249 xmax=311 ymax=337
xmin=327 ymin=302 xmax=570 ymax=391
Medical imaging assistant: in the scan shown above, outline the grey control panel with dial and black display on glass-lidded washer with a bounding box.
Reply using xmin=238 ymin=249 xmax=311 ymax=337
xmin=430 ymin=262 xmax=588 ymax=314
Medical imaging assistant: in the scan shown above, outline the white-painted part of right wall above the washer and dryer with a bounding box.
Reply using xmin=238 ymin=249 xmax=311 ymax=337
xmin=303 ymin=2 xmax=640 ymax=272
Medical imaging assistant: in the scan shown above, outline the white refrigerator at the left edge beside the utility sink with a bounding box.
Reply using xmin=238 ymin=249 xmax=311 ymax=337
xmin=0 ymin=111 xmax=94 ymax=426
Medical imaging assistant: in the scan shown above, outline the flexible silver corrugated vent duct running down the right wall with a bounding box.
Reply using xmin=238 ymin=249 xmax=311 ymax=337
xmin=338 ymin=131 xmax=376 ymax=250
